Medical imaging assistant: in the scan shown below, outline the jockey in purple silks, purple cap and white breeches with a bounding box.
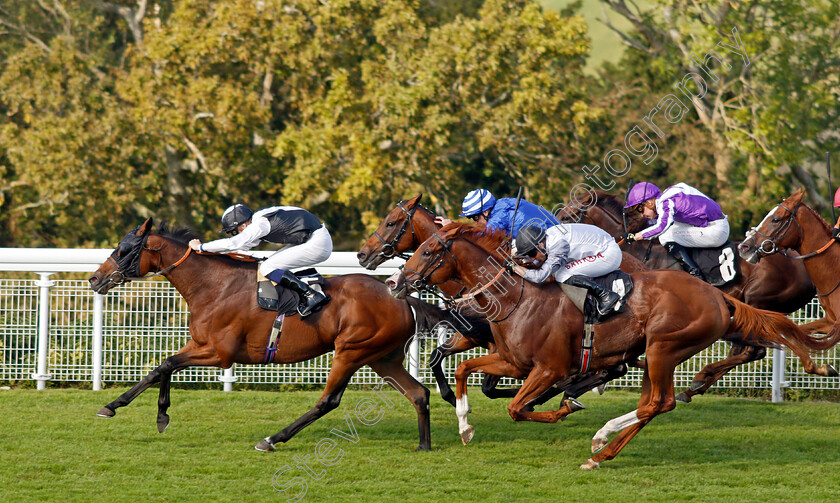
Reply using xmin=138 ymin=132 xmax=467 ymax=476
xmin=625 ymin=182 xmax=729 ymax=279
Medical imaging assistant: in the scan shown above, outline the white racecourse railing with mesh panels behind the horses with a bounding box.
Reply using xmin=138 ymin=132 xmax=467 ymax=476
xmin=0 ymin=248 xmax=840 ymax=400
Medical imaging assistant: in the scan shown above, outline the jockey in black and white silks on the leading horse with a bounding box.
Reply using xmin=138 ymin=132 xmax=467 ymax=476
xmin=190 ymin=204 xmax=332 ymax=316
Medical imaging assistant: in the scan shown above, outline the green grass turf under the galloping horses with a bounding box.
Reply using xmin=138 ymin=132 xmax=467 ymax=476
xmin=0 ymin=388 xmax=840 ymax=503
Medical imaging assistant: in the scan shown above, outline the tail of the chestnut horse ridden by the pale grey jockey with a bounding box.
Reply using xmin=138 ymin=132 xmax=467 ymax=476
xmin=723 ymin=293 xmax=840 ymax=352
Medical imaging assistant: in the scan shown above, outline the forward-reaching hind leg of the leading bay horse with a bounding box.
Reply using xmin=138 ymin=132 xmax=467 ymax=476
xmin=254 ymin=352 xmax=362 ymax=452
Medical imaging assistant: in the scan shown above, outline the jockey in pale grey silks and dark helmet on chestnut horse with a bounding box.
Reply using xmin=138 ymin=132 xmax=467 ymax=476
xmin=513 ymin=224 xmax=622 ymax=316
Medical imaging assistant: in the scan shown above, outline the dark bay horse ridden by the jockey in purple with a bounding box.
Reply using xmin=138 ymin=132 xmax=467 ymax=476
xmin=557 ymin=191 xmax=824 ymax=403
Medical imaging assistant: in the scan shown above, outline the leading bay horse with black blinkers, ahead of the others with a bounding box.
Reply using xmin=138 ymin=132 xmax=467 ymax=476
xmin=89 ymin=218 xmax=480 ymax=451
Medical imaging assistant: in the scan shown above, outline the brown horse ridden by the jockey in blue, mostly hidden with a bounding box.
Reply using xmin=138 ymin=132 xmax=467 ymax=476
xmin=356 ymin=194 xmax=646 ymax=412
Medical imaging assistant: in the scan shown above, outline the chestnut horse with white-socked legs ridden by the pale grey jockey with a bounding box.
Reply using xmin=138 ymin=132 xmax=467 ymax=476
xmin=387 ymin=224 xmax=837 ymax=469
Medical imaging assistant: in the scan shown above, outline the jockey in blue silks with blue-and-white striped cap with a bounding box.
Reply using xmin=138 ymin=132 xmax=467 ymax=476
xmin=435 ymin=189 xmax=560 ymax=238
